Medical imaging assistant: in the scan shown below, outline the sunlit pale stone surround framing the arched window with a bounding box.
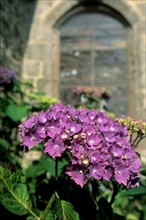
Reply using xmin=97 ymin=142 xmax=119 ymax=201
xmin=22 ymin=0 xmax=146 ymax=118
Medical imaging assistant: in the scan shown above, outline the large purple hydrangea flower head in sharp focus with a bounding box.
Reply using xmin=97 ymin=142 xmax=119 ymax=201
xmin=19 ymin=103 xmax=141 ymax=188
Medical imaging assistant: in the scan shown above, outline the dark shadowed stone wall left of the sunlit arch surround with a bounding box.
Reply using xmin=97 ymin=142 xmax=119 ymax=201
xmin=0 ymin=0 xmax=35 ymax=75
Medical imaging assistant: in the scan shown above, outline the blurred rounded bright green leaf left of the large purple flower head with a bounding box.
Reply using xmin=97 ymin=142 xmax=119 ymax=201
xmin=5 ymin=104 xmax=27 ymax=122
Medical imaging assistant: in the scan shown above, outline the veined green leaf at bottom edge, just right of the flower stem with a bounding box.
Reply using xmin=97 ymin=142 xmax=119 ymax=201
xmin=55 ymin=199 xmax=79 ymax=220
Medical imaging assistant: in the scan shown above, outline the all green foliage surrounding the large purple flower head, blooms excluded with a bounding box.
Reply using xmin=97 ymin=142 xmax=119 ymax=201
xmin=0 ymin=68 xmax=146 ymax=220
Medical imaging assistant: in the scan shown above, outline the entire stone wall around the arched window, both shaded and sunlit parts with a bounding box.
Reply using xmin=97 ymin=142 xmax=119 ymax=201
xmin=1 ymin=0 xmax=146 ymax=122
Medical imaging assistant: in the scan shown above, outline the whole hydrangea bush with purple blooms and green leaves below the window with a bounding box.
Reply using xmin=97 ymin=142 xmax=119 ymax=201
xmin=0 ymin=67 xmax=146 ymax=220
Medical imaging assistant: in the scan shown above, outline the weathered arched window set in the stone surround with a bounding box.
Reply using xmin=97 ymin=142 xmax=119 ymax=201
xmin=60 ymin=8 xmax=128 ymax=116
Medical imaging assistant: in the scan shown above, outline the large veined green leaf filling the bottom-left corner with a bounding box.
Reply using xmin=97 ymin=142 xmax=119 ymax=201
xmin=0 ymin=166 xmax=37 ymax=215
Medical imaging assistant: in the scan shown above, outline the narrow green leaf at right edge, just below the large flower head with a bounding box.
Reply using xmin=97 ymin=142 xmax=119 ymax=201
xmin=121 ymin=186 xmax=146 ymax=196
